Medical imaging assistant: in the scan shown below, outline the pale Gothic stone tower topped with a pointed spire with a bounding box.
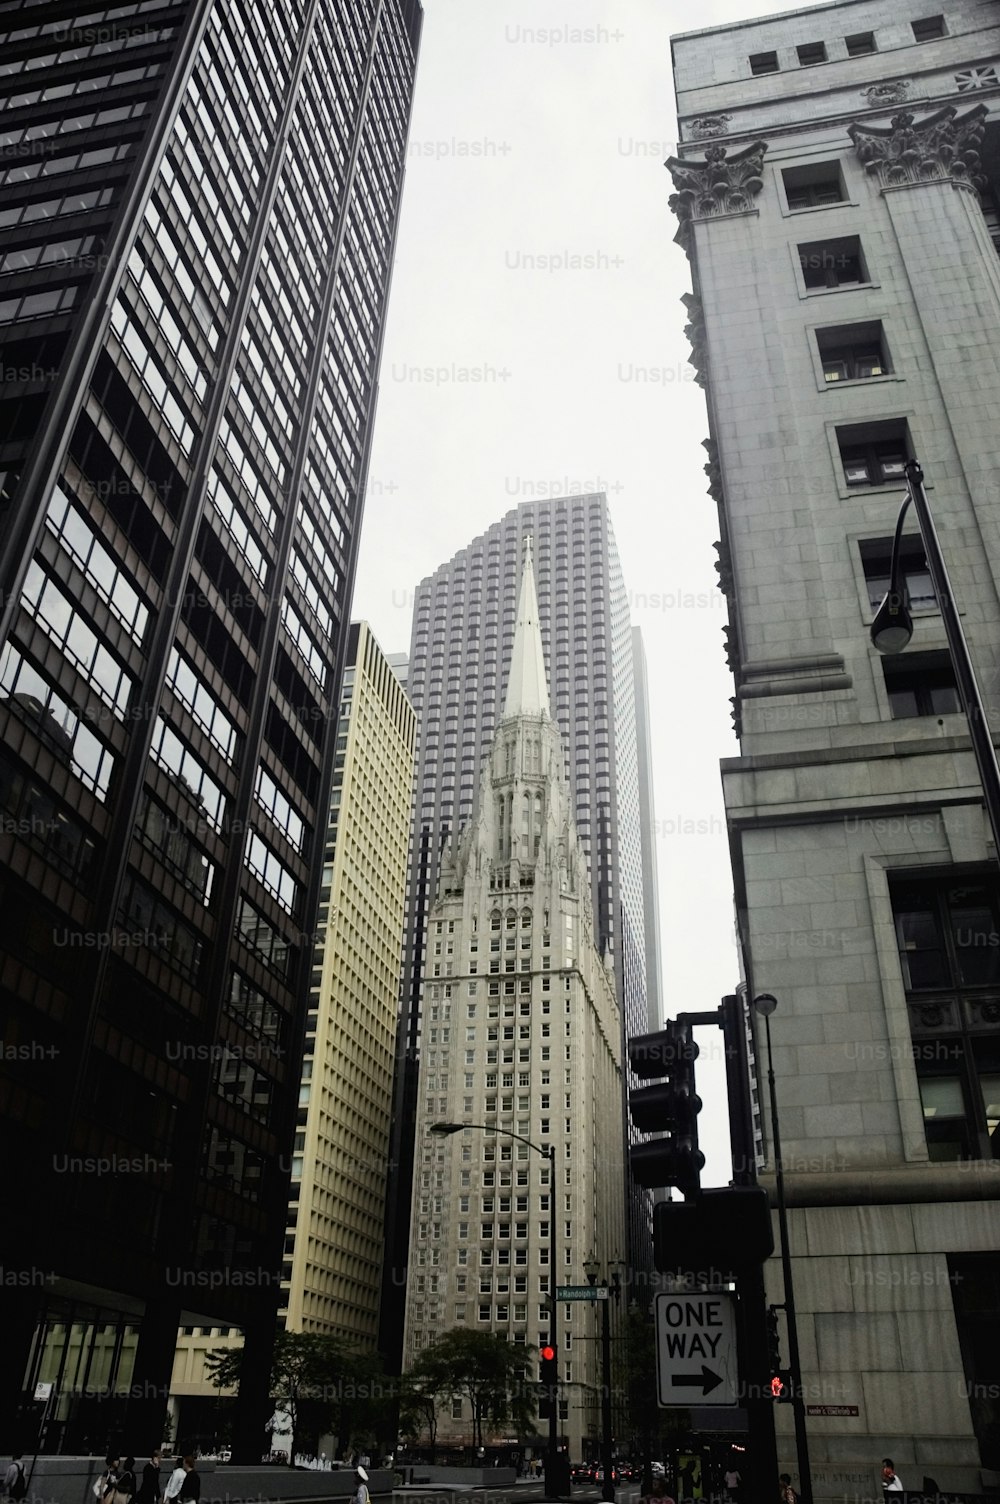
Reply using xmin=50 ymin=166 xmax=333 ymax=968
xmin=405 ymin=549 xmax=626 ymax=1457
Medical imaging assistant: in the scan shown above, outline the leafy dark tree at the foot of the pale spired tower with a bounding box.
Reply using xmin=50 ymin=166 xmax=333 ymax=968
xmin=412 ymin=1327 xmax=537 ymax=1450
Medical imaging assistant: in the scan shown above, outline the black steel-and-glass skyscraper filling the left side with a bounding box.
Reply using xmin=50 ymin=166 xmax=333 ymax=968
xmin=0 ymin=0 xmax=421 ymax=1457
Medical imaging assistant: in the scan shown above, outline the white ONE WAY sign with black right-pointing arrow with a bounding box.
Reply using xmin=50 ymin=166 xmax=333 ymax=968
xmin=656 ymin=1290 xmax=738 ymax=1406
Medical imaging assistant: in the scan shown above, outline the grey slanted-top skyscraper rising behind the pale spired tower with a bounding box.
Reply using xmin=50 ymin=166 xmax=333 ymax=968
xmin=383 ymin=493 xmax=657 ymax=1352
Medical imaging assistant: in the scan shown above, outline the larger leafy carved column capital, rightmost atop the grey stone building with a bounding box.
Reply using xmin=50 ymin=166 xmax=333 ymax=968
xmin=847 ymin=104 xmax=988 ymax=190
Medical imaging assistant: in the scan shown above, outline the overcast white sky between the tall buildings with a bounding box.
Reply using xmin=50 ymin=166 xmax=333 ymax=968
xmin=352 ymin=0 xmax=797 ymax=1184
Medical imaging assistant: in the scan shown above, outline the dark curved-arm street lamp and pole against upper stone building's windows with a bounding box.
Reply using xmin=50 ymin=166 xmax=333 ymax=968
xmin=871 ymin=460 xmax=1000 ymax=859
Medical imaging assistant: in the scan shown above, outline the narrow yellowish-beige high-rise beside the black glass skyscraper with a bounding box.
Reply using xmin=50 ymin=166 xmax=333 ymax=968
xmin=281 ymin=621 xmax=417 ymax=1351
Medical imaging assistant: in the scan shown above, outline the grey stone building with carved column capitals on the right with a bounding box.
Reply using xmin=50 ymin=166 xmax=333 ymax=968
xmin=668 ymin=0 xmax=1000 ymax=1498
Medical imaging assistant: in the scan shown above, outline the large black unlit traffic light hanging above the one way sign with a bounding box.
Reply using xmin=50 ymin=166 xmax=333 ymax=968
xmin=629 ymin=1020 xmax=705 ymax=1197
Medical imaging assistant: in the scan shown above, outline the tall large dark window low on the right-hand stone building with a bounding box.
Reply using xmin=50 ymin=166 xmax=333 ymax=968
xmin=890 ymin=877 xmax=1000 ymax=1160
